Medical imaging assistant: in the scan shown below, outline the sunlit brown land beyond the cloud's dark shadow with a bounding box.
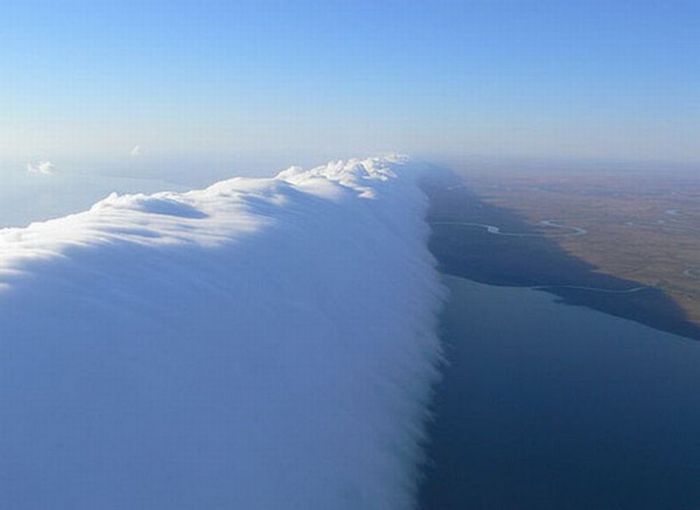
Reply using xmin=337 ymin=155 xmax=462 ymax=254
xmin=448 ymin=169 xmax=700 ymax=325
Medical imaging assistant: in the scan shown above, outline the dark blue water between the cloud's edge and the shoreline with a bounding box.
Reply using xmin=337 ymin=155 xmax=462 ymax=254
xmin=420 ymin=277 xmax=700 ymax=510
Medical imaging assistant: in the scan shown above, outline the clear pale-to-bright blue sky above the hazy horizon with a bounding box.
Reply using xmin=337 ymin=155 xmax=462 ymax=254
xmin=0 ymin=0 xmax=700 ymax=167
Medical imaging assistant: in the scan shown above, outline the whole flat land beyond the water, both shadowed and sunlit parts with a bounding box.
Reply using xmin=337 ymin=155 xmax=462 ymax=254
xmin=427 ymin=163 xmax=700 ymax=338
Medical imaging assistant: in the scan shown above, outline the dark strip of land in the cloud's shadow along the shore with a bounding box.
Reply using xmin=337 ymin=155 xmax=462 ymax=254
xmin=422 ymin=169 xmax=700 ymax=340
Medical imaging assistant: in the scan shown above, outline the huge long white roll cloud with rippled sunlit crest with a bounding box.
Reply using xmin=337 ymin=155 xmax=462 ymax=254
xmin=0 ymin=158 xmax=442 ymax=510
